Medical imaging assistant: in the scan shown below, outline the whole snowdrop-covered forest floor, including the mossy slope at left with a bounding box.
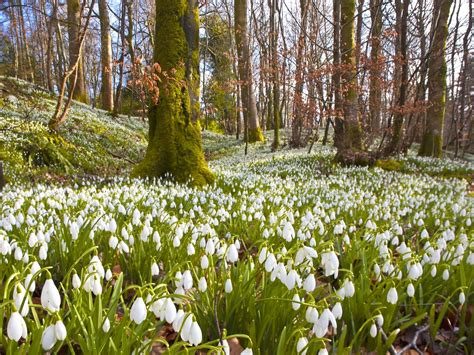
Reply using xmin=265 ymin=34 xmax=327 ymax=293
xmin=0 ymin=78 xmax=474 ymax=355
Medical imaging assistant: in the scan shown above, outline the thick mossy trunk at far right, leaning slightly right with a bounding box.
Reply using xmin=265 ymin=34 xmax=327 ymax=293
xmin=418 ymin=0 xmax=453 ymax=158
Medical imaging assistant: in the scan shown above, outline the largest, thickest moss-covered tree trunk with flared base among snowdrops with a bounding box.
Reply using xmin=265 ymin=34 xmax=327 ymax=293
xmin=132 ymin=0 xmax=213 ymax=185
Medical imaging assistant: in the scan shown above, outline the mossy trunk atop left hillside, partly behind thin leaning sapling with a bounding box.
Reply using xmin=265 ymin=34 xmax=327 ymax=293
xmin=67 ymin=0 xmax=89 ymax=103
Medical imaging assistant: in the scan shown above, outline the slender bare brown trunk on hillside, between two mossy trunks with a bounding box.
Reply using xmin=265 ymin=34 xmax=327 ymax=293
xmin=99 ymin=0 xmax=114 ymax=112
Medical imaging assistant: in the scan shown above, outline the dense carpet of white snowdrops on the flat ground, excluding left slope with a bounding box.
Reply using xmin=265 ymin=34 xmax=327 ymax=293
xmin=0 ymin=146 xmax=474 ymax=354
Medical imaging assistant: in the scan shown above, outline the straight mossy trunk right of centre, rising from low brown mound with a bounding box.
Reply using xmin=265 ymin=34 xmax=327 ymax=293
xmin=338 ymin=0 xmax=362 ymax=150
